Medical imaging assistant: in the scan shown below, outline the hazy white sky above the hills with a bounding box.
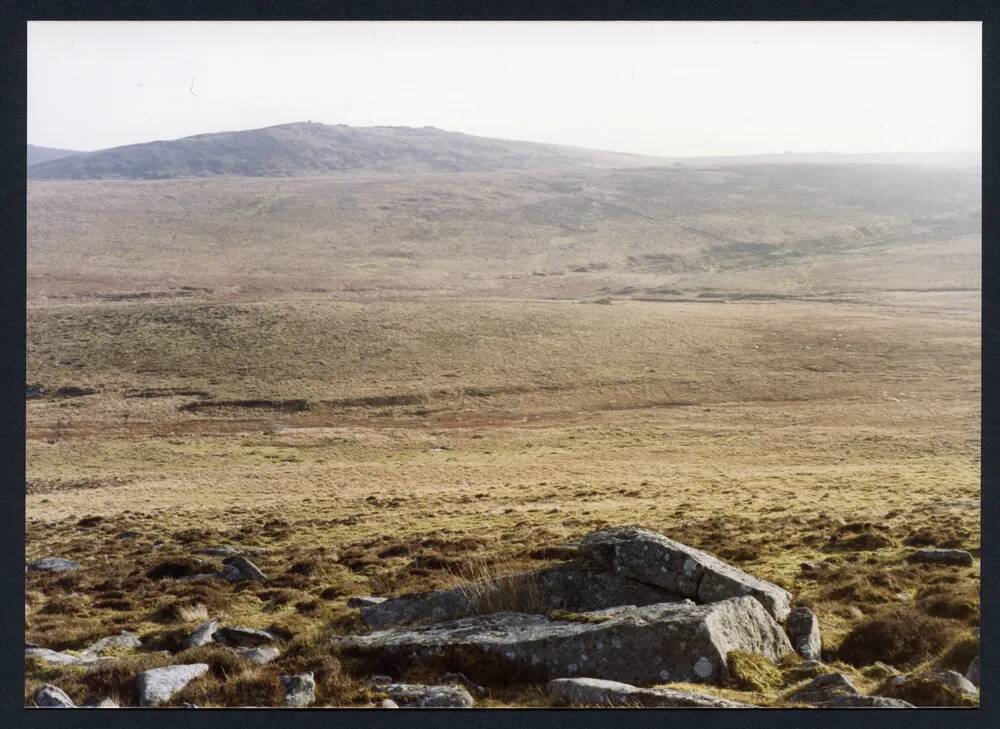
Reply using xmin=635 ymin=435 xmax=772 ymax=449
xmin=28 ymin=22 xmax=982 ymax=156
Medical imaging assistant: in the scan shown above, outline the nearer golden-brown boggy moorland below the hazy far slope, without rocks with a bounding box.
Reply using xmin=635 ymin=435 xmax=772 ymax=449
xmin=25 ymin=292 xmax=980 ymax=706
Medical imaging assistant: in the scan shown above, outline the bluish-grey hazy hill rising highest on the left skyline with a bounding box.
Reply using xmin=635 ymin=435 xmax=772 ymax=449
xmin=29 ymin=122 xmax=663 ymax=180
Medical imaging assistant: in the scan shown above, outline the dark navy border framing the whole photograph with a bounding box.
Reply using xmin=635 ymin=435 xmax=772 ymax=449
xmin=0 ymin=5 xmax=1000 ymax=729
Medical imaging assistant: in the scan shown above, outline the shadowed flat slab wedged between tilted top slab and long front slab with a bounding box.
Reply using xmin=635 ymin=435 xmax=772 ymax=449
xmin=358 ymin=560 xmax=683 ymax=628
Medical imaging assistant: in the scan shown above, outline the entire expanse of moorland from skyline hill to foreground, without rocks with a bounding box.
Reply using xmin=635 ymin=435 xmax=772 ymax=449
xmin=25 ymin=125 xmax=981 ymax=707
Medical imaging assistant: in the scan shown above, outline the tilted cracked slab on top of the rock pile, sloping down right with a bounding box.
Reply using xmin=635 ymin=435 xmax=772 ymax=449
xmin=580 ymin=527 xmax=791 ymax=622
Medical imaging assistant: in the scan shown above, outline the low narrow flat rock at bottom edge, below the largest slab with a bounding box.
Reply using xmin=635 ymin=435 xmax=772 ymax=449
xmin=547 ymin=678 xmax=755 ymax=709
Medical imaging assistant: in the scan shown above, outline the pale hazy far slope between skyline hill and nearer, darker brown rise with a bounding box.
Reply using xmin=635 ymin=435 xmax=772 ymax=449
xmin=28 ymin=158 xmax=981 ymax=301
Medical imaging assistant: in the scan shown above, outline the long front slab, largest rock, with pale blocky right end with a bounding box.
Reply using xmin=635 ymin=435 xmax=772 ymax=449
xmin=333 ymin=597 xmax=792 ymax=684
